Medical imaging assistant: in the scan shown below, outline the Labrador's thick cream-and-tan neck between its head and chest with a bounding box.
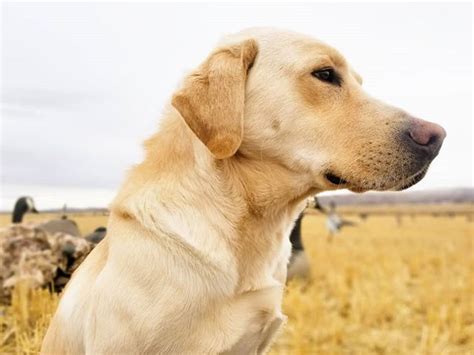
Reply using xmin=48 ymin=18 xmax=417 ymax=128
xmin=112 ymin=113 xmax=309 ymax=289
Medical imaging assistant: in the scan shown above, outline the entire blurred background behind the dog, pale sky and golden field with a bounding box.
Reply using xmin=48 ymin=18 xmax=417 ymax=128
xmin=0 ymin=1 xmax=474 ymax=354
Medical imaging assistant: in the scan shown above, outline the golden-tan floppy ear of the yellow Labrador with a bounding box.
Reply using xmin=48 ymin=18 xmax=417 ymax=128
xmin=172 ymin=40 xmax=258 ymax=159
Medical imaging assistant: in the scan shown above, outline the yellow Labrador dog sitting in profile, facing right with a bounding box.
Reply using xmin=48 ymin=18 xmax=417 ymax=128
xmin=42 ymin=29 xmax=445 ymax=354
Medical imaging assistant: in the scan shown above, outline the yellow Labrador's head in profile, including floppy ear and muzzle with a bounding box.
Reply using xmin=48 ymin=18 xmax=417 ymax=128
xmin=172 ymin=29 xmax=446 ymax=191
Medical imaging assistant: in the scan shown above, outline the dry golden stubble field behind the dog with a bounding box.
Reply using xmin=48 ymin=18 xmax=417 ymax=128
xmin=0 ymin=207 xmax=474 ymax=354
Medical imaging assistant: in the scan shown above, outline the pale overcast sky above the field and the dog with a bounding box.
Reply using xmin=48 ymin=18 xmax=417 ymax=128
xmin=0 ymin=2 xmax=472 ymax=209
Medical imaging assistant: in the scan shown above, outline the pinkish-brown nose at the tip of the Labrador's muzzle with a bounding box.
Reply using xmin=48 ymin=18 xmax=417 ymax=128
xmin=408 ymin=119 xmax=446 ymax=158
